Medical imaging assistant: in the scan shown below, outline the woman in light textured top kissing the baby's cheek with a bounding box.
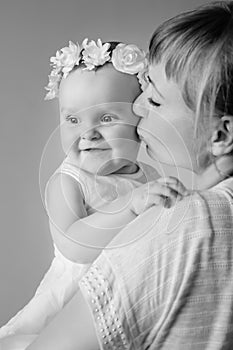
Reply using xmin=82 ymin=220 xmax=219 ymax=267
xmin=16 ymin=2 xmax=233 ymax=350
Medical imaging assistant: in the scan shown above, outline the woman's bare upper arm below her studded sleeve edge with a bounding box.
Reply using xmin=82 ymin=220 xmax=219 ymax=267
xmin=26 ymin=291 xmax=99 ymax=350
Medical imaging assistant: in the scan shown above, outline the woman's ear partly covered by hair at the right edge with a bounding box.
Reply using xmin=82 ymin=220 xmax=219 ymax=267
xmin=211 ymin=115 xmax=233 ymax=157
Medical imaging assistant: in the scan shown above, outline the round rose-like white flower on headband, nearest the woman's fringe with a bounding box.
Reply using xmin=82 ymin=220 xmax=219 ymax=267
xmin=112 ymin=44 xmax=146 ymax=74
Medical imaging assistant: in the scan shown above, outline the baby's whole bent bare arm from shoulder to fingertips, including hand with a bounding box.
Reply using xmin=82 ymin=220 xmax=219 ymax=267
xmin=47 ymin=174 xmax=186 ymax=263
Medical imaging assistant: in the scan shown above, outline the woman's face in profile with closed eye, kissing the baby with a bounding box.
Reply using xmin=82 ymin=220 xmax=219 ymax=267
xmin=134 ymin=63 xmax=198 ymax=171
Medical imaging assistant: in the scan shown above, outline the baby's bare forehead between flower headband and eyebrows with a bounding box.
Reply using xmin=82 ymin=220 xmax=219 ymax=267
xmin=59 ymin=64 xmax=141 ymax=106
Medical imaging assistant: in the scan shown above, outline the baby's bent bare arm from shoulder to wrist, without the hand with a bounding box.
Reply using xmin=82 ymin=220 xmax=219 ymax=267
xmin=46 ymin=174 xmax=136 ymax=263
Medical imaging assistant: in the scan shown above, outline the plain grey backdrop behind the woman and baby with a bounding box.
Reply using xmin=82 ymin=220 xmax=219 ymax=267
xmin=0 ymin=0 xmax=218 ymax=325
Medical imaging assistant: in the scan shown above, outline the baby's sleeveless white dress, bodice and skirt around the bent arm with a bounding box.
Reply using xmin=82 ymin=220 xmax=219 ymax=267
xmin=0 ymin=158 xmax=158 ymax=349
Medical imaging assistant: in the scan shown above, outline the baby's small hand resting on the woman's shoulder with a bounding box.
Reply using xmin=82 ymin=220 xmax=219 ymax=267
xmin=131 ymin=176 xmax=189 ymax=215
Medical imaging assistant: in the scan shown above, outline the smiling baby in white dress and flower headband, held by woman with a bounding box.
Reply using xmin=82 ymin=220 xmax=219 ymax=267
xmin=0 ymin=39 xmax=185 ymax=349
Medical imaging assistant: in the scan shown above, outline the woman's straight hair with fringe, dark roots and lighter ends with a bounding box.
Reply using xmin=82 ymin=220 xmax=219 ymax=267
xmin=149 ymin=1 xmax=233 ymax=165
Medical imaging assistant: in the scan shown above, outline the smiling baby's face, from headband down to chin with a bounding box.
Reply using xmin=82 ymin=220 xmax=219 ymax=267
xmin=59 ymin=64 xmax=140 ymax=175
